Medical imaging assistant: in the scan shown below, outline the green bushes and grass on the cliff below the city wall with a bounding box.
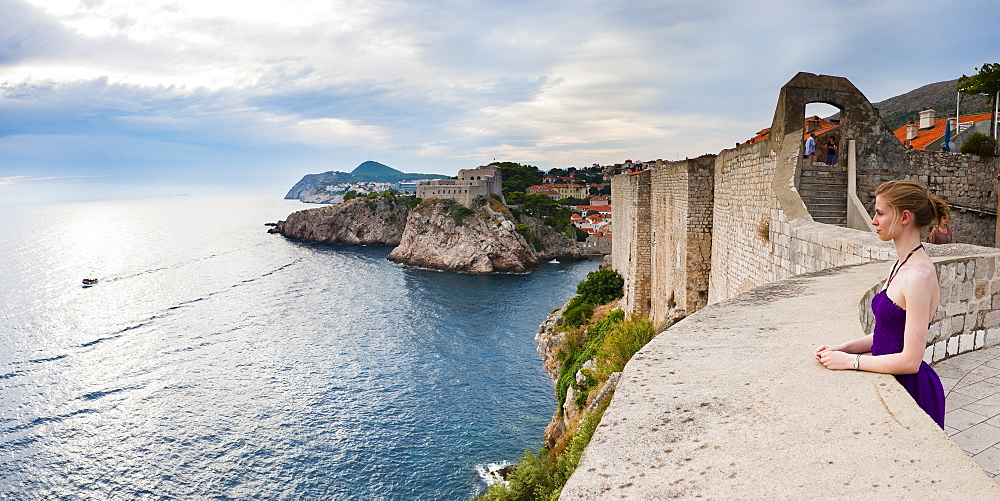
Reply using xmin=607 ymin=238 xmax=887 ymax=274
xmin=479 ymin=269 xmax=656 ymax=501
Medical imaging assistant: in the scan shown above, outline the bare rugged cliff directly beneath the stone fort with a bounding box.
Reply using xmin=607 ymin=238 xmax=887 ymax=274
xmin=389 ymin=198 xmax=540 ymax=274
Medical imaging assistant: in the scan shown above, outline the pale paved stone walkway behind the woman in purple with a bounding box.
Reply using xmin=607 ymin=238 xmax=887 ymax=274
xmin=934 ymin=347 xmax=1000 ymax=482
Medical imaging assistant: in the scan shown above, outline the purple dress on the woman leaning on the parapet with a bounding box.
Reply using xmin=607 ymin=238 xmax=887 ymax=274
xmin=872 ymin=290 xmax=944 ymax=429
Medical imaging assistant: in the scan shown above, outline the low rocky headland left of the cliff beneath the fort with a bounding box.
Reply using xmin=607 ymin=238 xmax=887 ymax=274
xmin=269 ymin=198 xmax=410 ymax=245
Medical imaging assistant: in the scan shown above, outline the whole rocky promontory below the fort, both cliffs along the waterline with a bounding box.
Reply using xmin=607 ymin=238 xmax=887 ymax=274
xmin=268 ymin=196 xmax=587 ymax=274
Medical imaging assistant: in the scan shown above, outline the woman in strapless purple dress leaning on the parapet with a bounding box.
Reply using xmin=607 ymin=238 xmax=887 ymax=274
xmin=816 ymin=181 xmax=948 ymax=428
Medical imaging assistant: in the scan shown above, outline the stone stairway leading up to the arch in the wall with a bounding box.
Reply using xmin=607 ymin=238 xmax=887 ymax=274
xmin=798 ymin=162 xmax=847 ymax=226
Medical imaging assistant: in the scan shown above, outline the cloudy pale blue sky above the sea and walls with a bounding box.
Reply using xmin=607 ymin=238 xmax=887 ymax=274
xmin=0 ymin=0 xmax=1000 ymax=204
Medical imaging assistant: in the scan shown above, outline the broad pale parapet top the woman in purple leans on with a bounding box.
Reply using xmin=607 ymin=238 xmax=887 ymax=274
xmin=561 ymin=256 xmax=1000 ymax=500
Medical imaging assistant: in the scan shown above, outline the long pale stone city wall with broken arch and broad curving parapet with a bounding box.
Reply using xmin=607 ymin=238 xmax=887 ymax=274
xmin=561 ymin=73 xmax=1000 ymax=499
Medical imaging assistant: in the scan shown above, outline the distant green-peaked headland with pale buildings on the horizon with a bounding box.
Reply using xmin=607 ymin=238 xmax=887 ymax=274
xmin=285 ymin=160 xmax=448 ymax=203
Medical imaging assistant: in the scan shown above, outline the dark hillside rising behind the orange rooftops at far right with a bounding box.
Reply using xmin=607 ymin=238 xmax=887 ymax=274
xmin=874 ymin=79 xmax=991 ymax=130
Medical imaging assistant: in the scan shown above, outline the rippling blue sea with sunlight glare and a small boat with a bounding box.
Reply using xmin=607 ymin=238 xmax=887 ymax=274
xmin=0 ymin=197 xmax=597 ymax=500
